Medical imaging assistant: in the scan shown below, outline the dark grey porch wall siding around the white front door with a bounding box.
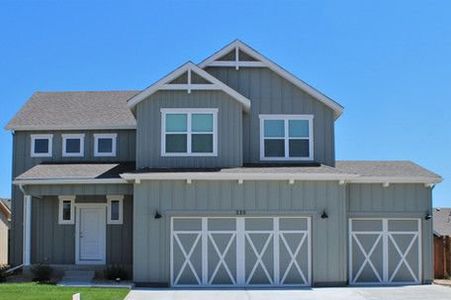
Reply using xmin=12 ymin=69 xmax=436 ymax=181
xmin=31 ymin=196 xmax=133 ymax=266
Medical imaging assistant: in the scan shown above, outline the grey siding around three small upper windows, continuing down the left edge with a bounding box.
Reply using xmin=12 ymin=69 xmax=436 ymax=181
xmin=10 ymin=130 xmax=136 ymax=266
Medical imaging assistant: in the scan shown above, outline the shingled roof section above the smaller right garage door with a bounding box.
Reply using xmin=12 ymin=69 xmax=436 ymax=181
xmin=336 ymin=160 xmax=442 ymax=183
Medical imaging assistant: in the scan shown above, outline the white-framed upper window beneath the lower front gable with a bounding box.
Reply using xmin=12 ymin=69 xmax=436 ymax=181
xmin=161 ymin=108 xmax=218 ymax=156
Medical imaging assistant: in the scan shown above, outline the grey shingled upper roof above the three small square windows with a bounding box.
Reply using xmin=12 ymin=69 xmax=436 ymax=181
xmin=6 ymin=91 xmax=139 ymax=130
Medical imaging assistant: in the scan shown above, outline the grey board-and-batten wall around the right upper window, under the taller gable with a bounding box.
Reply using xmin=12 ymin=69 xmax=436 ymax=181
xmin=206 ymin=67 xmax=335 ymax=166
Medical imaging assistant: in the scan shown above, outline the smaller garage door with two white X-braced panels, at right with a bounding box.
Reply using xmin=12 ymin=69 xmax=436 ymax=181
xmin=349 ymin=218 xmax=421 ymax=284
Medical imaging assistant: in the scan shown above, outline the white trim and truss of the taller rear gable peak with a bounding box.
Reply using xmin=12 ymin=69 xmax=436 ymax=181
xmin=199 ymin=40 xmax=343 ymax=118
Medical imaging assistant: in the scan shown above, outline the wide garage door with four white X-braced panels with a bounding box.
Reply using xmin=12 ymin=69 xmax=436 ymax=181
xmin=171 ymin=217 xmax=311 ymax=287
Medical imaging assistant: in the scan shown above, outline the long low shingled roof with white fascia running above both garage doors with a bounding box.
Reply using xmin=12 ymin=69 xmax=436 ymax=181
xmin=121 ymin=161 xmax=442 ymax=185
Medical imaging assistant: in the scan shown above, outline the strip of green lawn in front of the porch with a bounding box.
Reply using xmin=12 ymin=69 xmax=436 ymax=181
xmin=0 ymin=283 xmax=129 ymax=300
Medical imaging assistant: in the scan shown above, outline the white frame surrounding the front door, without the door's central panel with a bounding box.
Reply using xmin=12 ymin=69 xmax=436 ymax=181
xmin=75 ymin=203 xmax=106 ymax=265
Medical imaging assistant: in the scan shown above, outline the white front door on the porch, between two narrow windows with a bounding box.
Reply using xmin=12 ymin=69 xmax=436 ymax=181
xmin=75 ymin=204 xmax=106 ymax=264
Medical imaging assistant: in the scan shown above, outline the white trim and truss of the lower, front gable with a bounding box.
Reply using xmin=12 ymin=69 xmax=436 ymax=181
xmin=128 ymin=62 xmax=251 ymax=110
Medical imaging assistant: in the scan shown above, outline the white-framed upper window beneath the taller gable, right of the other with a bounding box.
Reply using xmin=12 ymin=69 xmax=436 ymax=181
xmin=260 ymin=115 xmax=313 ymax=160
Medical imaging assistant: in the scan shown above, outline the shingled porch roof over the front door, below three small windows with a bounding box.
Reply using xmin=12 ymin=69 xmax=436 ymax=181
xmin=14 ymin=163 xmax=135 ymax=185
